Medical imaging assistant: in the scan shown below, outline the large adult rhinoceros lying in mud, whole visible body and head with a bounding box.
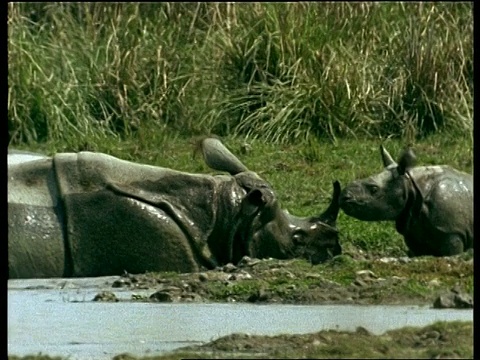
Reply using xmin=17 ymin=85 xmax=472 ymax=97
xmin=8 ymin=138 xmax=341 ymax=278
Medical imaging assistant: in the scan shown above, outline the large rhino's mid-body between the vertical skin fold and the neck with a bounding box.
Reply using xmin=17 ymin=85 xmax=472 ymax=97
xmin=54 ymin=152 xmax=233 ymax=276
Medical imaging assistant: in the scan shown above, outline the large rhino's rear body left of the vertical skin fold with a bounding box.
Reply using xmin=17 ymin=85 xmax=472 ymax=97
xmin=8 ymin=158 xmax=70 ymax=278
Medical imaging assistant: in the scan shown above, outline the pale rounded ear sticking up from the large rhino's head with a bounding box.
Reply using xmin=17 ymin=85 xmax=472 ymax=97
xmin=198 ymin=138 xmax=248 ymax=175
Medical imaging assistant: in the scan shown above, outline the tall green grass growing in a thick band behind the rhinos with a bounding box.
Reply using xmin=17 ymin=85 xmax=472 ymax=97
xmin=8 ymin=2 xmax=473 ymax=150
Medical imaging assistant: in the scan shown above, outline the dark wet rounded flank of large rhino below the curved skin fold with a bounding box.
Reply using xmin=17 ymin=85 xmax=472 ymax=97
xmin=65 ymin=191 xmax=216 ymax=276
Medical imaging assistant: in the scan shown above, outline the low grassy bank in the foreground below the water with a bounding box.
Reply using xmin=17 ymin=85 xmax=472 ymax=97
xmin=8 ymin=321 xmax=473 ymax=360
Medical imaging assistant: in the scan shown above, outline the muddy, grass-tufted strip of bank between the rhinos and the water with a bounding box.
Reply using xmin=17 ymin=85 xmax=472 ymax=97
xmin=95 ymin=249 xmax=473 ymax=308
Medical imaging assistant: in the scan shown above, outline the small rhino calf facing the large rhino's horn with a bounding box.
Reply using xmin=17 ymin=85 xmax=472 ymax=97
xmin=340 ymin=146 xmax=473 ymax=256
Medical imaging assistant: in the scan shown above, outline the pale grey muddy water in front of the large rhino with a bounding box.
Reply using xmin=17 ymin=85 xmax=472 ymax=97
xmin=8 ymin=278 xmax=473 ymax=360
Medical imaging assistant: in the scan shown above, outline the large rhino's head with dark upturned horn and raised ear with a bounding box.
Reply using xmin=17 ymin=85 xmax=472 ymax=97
xmin=200 ymin=138 xmax=341 ymax=264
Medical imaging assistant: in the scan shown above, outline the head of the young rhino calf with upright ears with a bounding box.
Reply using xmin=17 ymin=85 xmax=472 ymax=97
xmin=340 ymin=145 xmax=415 ymax=221
